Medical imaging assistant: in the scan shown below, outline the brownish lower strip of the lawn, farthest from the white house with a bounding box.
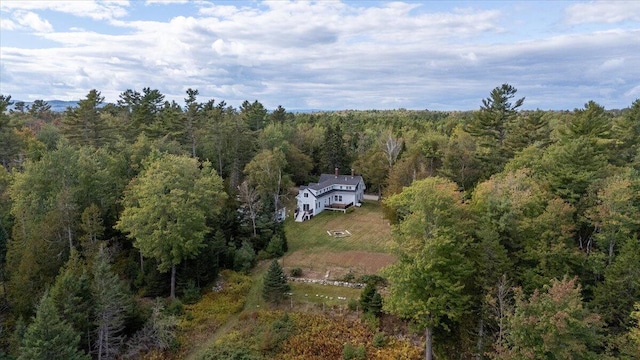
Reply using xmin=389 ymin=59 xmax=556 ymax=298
xmin=283 ymin=251 xmax=396 ymax=280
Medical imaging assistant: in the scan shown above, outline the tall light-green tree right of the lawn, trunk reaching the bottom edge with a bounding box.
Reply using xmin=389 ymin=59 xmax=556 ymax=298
xmin=385 ymin=177 xmax=472 ymax=360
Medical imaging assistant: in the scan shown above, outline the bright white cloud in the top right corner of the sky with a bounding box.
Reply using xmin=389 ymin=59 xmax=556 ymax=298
xmin=565 ymin=0 xmax=640 ymax=25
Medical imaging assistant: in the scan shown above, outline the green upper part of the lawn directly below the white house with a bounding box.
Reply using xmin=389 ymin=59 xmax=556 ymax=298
xmin=285 ymin=202 xmax=391 ymax=253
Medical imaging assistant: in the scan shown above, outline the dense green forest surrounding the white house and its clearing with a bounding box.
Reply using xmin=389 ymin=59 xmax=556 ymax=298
xmin=0 ymin=84 xmax=640 ymax=359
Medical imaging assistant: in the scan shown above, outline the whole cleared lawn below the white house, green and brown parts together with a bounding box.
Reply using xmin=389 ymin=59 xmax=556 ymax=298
xmin=283 ymin=202 xmax=395 ymax=279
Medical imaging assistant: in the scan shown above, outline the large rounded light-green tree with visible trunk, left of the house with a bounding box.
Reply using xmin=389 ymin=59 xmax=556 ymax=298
xmin=116 ymin=155 xmax=226 ymax=298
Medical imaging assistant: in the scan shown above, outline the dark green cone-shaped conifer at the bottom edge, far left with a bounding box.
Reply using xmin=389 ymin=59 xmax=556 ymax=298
xmin=18 ymin=292 xmax=89 ymax=360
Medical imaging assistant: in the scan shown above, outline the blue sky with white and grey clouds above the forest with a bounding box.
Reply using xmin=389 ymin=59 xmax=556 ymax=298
xmin=0 ymin=0 xmax=640 ymax=111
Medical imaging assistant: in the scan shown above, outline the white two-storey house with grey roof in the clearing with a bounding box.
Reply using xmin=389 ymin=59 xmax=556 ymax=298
xmin=296 ymin=168 xmax=366 ymax=222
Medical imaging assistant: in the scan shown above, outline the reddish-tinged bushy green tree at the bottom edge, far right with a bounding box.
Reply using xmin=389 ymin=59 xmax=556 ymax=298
xmin=495 ymin=278 xmax=603 ymax=359
